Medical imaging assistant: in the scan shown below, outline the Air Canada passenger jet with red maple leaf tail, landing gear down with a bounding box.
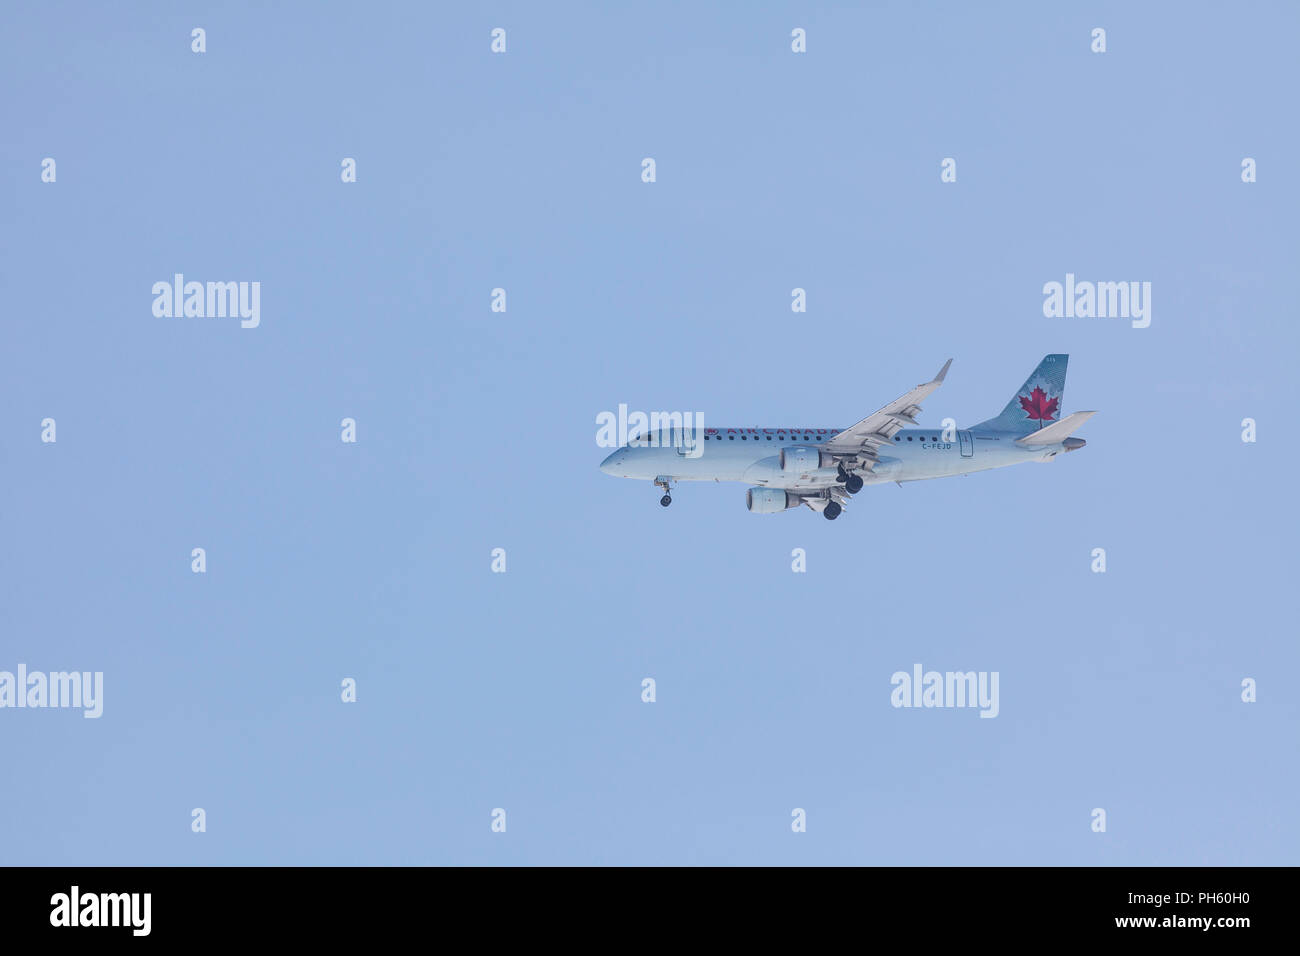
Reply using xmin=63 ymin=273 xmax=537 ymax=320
xmin=601 ymin=355 xmax=1096 ymax=520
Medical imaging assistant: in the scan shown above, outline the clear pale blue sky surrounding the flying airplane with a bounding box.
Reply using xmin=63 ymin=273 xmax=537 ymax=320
xmin=0 ymin=3 xmax=1300 ymax=865
